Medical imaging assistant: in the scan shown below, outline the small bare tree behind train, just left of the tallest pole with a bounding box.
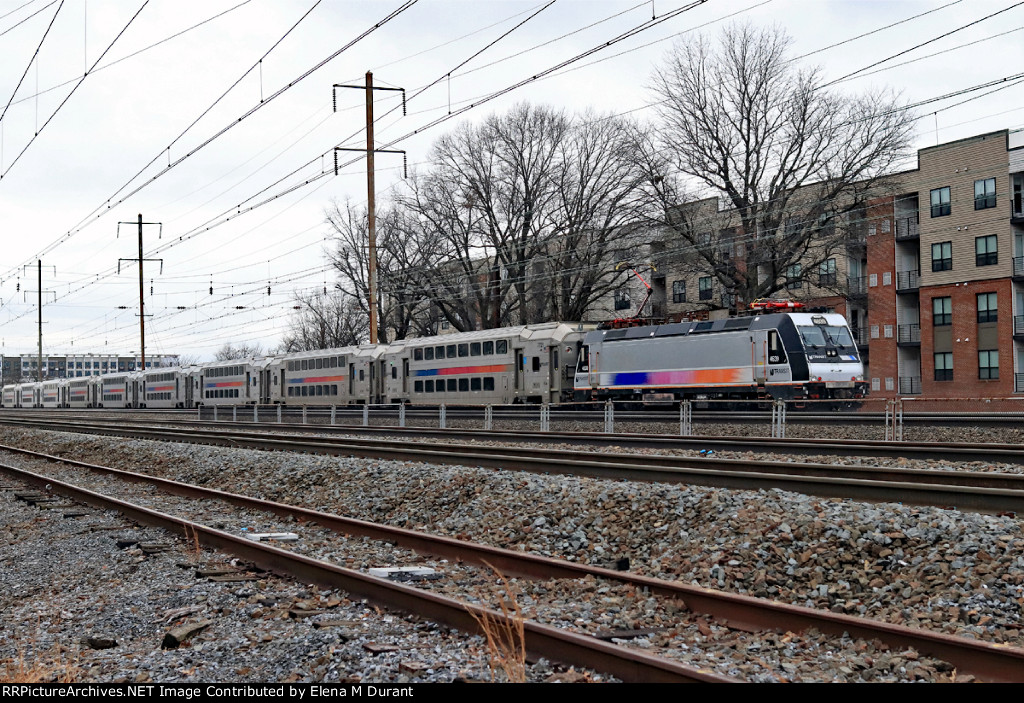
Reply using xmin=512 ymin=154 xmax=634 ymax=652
xmin=282 ymin=291 xmax=370 ymax=352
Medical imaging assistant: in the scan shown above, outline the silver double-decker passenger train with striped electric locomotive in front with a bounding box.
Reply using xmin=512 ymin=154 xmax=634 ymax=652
xmin=0 ymin=312 xmax=867 ymax=408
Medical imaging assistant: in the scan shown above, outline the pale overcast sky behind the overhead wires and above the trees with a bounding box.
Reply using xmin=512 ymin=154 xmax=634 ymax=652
xmin=0 ymin=0 xmax=1024 ymax=358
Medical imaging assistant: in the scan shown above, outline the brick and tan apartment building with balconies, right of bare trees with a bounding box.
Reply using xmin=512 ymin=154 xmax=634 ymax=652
xmin=627 ymin=130 xmax=1024 ymax=399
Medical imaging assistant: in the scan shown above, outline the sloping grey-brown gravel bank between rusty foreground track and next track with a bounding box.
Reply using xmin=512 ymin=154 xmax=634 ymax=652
xmin=0 ymin=423 xmax=1024 ymax=680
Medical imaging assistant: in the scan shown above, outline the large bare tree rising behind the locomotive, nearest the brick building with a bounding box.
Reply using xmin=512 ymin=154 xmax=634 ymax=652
xmin=647 ymin=25 xmax=912 ymax=302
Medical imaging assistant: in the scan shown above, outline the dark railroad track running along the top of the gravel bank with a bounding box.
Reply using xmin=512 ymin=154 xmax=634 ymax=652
xmin=0 ymin=419 xmax=1024 ymax=513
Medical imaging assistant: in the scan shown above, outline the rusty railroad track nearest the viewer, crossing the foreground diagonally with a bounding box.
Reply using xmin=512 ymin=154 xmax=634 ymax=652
xmin=0 ymin=447 xmax=1024 ymax=683
